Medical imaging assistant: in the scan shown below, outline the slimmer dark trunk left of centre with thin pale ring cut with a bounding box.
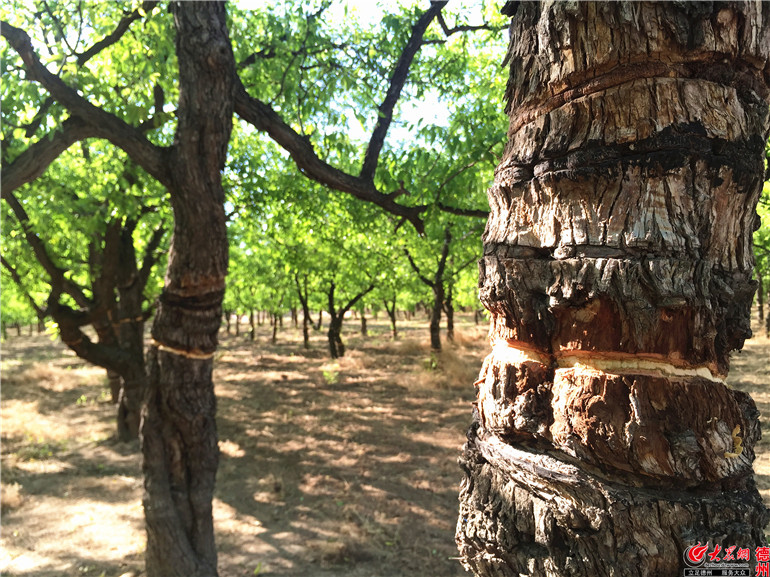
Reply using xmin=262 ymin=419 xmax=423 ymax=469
xmin=142 ymin=2 xmax=235 ymax=577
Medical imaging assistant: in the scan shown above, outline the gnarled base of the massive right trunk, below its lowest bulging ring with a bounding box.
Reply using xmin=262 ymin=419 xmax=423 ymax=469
xmin=456 ymin=422 xmax=769 ymax=577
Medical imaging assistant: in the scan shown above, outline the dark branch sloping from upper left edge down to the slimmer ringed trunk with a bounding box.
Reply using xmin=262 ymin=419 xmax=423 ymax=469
xmin=0 ymin=21 xmax=170 ymax=185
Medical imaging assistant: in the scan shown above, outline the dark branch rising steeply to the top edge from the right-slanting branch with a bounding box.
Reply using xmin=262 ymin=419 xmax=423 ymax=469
xmin=360 ymin=0 xmax=448 ymax=181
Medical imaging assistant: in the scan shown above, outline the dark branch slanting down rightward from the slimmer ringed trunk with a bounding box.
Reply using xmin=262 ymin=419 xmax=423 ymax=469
xmin=235 ymin=79 xmax=427 ymax=234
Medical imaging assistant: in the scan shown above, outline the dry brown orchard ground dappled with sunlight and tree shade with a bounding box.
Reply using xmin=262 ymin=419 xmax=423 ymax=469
xmin=0 ymin=315 xmax=770 ymax=577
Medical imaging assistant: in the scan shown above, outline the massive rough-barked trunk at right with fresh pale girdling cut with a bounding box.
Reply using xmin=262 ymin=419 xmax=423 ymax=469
xmin=457 ymin=2 xmax=770 ymax=577
